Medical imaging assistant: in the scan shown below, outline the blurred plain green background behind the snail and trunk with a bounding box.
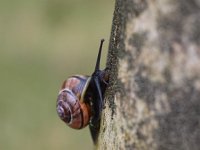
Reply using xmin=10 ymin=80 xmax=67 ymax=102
xmin=0 ymin=0 xmax=114 ymax=150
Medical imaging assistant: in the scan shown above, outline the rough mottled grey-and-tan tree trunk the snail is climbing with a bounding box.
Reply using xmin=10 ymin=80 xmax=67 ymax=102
xmin=96 ymin=0 xmax=200 ymax=150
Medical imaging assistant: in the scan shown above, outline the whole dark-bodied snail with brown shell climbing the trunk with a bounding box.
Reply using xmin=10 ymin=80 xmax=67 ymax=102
xmin=57 ymin=39 xmax=108 ymax=143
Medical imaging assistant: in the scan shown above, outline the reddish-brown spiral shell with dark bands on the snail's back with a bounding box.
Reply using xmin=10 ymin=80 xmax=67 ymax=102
xmin=57 ymin=75 xmax=91 ymax=129
